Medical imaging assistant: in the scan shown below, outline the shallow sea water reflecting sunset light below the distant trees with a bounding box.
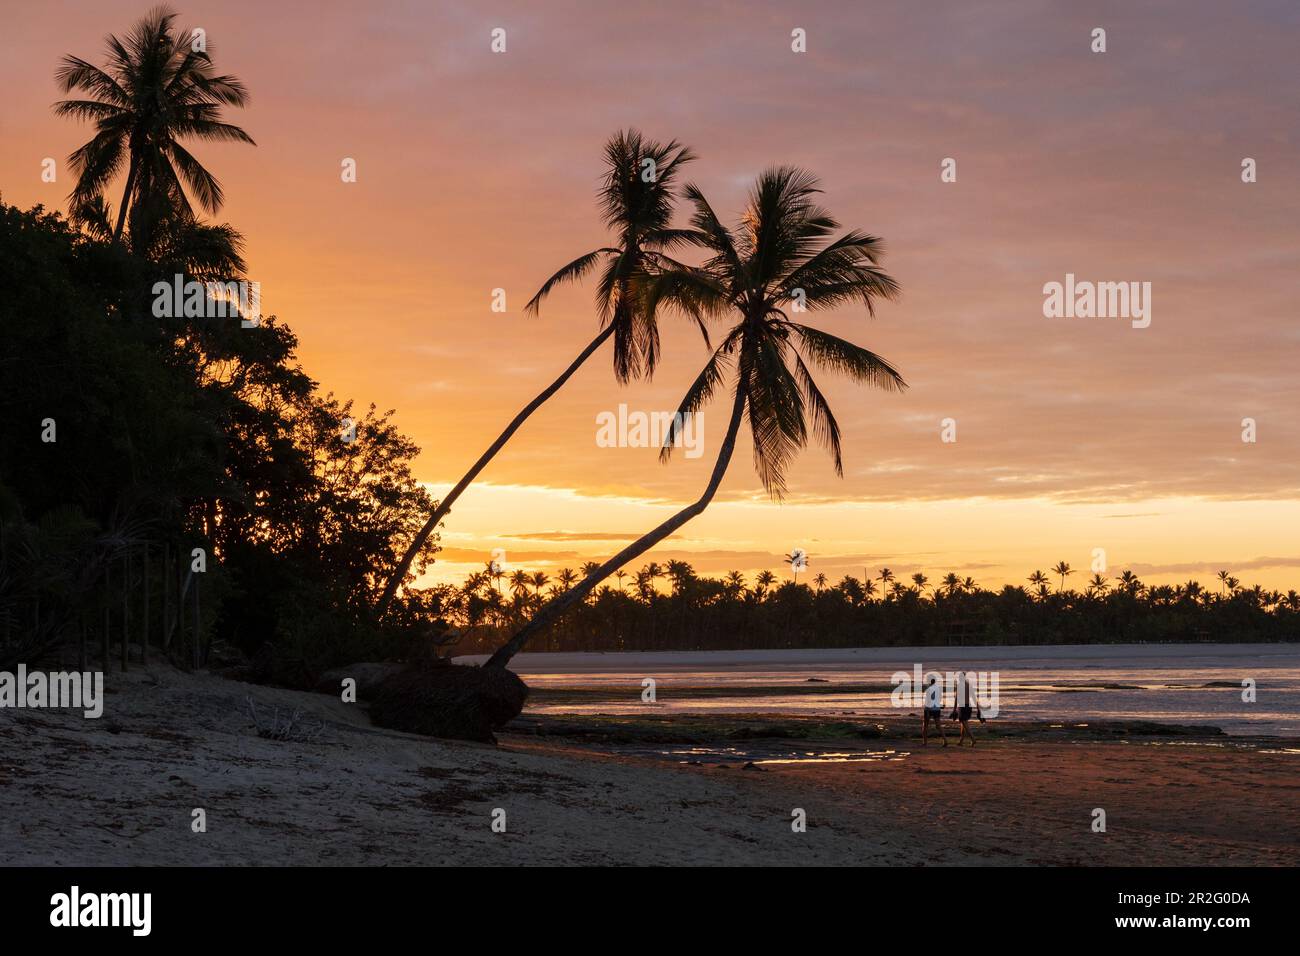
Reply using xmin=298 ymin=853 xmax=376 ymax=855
xmin=462 ymin=644 xmax=1300 ymax=737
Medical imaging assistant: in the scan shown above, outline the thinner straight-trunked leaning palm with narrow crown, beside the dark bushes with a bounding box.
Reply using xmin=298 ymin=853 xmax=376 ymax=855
xmin=376 ymin=130 xmax=707 ymax=617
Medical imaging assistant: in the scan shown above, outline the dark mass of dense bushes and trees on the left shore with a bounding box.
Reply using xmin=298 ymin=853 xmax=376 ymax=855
xmin=0 ymin=204 xmax=437 ymax=666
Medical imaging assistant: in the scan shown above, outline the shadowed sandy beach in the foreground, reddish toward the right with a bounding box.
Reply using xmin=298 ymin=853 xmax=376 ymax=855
xmin=0 ymin=666 xmax=1300 ymax=865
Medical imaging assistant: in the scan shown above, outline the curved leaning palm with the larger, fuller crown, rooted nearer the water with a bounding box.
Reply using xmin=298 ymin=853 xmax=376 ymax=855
xmin=486 ymin=166 xmax=905 ymax=667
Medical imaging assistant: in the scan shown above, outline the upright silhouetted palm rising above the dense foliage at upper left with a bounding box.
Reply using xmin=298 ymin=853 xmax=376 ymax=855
xmin=55 ymin=7 xmax=254 ymax=251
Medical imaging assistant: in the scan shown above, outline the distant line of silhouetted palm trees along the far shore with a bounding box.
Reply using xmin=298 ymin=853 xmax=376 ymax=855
xmin=412 ymin=561 xmax=1300 ymax=654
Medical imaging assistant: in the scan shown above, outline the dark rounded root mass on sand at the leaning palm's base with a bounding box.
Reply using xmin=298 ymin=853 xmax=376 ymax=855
xmin=371 ymin=665 xmax=528 ymax=744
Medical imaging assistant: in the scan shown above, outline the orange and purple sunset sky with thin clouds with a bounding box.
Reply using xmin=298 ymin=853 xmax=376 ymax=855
xmin=0 ymin=0 xmax=1300 ymax=589
